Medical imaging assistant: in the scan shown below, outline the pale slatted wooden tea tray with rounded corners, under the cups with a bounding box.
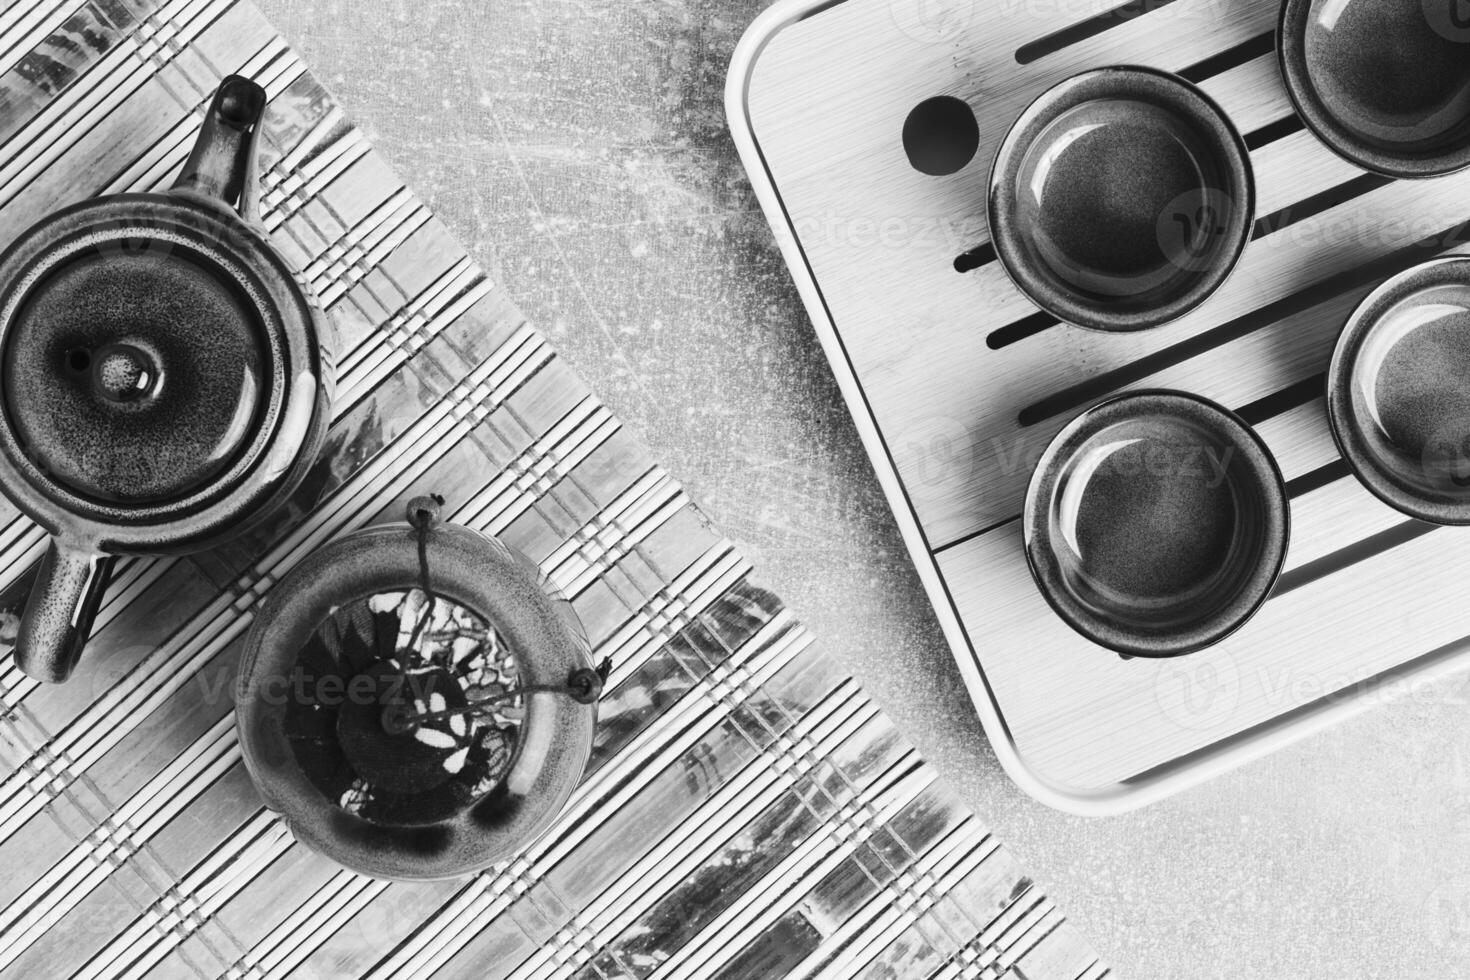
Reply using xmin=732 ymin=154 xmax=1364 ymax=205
xmin=728 ymin=0 xmax=1470 ymax=813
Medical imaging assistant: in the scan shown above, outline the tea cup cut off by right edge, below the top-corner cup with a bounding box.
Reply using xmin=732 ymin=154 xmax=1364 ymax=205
xmin=1327 ymin=256 xmax=1470 ymax=525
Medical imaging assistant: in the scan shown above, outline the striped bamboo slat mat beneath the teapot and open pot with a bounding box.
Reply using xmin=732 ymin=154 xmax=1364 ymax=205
xmin=0 ymin=0 xmax=1108 ymax=980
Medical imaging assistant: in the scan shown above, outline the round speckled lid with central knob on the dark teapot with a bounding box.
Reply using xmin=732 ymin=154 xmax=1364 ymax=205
xmin=0 ymin=238 xmax=275 ymax=507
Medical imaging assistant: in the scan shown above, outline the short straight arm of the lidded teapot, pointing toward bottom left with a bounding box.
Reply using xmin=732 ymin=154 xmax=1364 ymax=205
xmin=15 ymin=541 xmax=116 ymax=683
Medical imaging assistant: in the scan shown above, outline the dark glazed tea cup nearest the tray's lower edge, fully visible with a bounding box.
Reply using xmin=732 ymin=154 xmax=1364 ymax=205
xmin=1022 ymin=391 xmax=1289 ymax=657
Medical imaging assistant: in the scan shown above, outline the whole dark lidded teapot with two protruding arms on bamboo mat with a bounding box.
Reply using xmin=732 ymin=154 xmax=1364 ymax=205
xmin=0 ymin=76 xmax=334 ymax=682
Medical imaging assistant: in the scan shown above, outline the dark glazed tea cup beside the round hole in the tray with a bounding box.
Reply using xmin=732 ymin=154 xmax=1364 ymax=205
xmin=988 ymin=66 xmax=1255 ymax=331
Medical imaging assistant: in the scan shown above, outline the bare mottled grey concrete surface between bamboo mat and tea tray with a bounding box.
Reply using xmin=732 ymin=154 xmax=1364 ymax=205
xmin=259 ymin=0 xmax=1470 ymax=980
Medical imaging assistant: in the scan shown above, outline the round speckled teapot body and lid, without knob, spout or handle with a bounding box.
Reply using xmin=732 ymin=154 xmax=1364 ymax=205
xmin=0 ymin=207 xmax=291 ymax=514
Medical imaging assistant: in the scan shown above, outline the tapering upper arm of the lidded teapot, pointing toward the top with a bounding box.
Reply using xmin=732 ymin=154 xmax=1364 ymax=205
xmin=173 ymin=75 xmax=266 ymax=222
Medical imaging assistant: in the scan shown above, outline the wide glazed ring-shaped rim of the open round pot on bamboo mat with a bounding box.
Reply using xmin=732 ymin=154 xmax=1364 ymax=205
xmin=235 ymin=523 xmax=597 ymax=880
